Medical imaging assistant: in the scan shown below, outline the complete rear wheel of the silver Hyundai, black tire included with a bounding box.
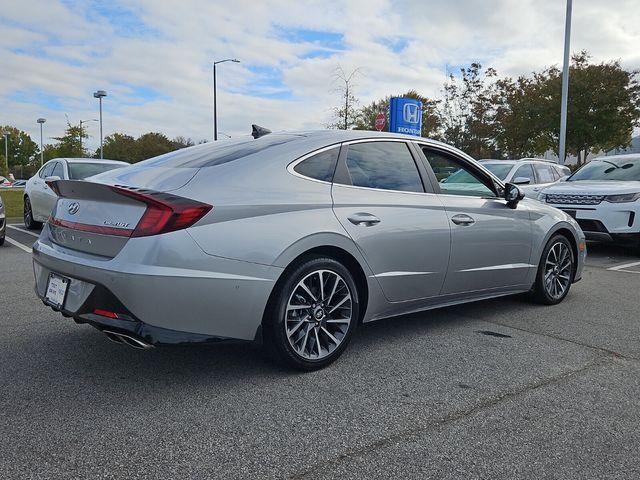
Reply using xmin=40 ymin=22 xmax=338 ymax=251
xmin=263 ymin=257 xmax=359 ymax=371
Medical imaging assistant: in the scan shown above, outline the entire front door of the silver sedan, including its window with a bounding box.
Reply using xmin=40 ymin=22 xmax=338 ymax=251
xmin=421 ymin=146 xmax=533 ymax=295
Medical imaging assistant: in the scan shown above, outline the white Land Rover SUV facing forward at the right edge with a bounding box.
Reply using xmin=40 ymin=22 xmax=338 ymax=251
xmin=539 ymin=154 xmax=640 ymax=251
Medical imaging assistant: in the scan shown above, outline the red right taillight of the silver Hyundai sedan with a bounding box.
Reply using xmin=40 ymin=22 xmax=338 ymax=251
xmin=110 ymin=186 xmax=213 ymax=237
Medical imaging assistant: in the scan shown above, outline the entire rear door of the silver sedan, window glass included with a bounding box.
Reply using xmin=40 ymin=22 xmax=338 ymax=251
xmin=332 ymin=141 xmax=451 ymax=302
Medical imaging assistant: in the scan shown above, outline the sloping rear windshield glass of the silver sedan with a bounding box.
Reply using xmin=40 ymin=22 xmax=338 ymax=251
xmin=138 ymin=135 xmax=298 ymax=168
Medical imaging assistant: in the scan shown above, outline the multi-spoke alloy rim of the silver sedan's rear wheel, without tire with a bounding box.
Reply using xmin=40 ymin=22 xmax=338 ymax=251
xmin=284 ymin=270 xmax=353 ymax=360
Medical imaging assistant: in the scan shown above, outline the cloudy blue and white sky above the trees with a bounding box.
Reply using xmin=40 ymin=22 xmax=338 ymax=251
xmin=0 ymin=0 xmax=640 ymax=148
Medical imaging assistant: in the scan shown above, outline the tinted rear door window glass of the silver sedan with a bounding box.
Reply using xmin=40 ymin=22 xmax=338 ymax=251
xmin=346 ymin=142 xmax=424 ymax=192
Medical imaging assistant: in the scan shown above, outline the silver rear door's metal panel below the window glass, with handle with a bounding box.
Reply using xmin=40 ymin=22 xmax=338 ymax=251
xmin=332 ymin=184 xmax=451 ymax=302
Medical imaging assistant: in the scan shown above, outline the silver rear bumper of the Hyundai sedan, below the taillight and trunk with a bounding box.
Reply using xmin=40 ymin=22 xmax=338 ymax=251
xmin=33 ymin=226 xmax=282 ymax=344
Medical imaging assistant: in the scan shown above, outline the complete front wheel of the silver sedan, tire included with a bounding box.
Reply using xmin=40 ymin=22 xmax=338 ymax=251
xmin=532 ymin=235 xmax=576 ymax=305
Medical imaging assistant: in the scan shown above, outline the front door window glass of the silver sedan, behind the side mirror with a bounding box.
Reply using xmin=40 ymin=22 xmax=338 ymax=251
xmin=422 ymin=148 xmax=495 ymax=197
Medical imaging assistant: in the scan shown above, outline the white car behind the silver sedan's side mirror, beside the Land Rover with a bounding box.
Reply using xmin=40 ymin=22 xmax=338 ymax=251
xmin=480 ymin=158 xmax=571 ymax=199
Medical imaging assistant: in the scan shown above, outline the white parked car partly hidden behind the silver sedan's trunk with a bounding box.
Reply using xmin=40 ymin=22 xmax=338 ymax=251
xmin=24 ymin=158 xmax=129 ymax=229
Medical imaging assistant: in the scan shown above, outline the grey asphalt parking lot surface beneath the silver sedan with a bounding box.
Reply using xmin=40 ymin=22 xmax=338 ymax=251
xmin=0 ymin=226 xmax=640 ymax=479
